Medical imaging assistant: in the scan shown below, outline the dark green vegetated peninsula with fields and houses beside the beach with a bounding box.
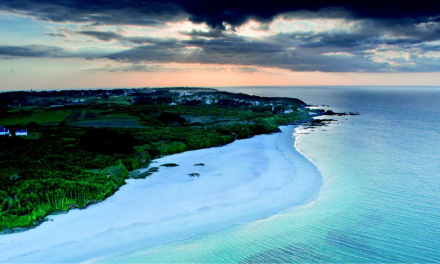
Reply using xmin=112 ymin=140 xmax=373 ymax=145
xmin=0 ymin=87 xmax=321 ymax=233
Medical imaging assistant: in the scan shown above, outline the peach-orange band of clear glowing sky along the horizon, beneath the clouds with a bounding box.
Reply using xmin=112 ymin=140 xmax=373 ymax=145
xmin=4 ymin=61 xmax=440 ymax=90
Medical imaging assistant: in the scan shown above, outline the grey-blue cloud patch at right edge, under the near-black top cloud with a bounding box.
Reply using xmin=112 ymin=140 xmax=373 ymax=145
xmin=270 ymin=20 xmax=440 ymax=55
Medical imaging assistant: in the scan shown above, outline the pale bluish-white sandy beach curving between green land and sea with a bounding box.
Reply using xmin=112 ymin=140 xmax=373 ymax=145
xmin=0 ymin=126 xmax=322 ymax=263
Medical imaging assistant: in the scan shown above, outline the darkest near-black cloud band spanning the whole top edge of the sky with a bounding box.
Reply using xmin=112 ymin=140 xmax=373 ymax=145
xmin=0 ymin=0 xmax=440 ymax=28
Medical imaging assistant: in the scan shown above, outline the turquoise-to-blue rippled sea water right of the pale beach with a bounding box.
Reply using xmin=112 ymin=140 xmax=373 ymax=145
xmin=117 ymin=87 xmax=440 ymax=262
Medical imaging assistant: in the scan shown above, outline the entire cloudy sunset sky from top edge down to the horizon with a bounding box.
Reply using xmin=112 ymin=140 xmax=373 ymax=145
xmin=0 ymin=0 xmax=440 ymax=90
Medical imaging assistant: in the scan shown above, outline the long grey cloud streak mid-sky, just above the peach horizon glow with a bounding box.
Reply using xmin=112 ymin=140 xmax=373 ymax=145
xmin=102 ymin=34 xmax=387 ymax=72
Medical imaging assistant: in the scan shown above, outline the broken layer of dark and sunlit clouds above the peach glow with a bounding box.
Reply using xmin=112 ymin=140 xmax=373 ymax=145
xmin=0 ymin=0 xmax=440 ymax=72
